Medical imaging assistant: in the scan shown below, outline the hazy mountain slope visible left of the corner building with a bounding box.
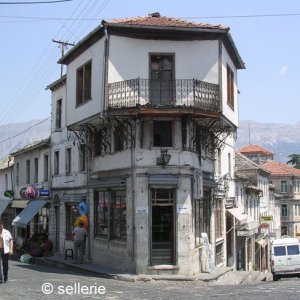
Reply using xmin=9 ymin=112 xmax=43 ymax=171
xmin=0 ymin=118 xmax=51 ymax=159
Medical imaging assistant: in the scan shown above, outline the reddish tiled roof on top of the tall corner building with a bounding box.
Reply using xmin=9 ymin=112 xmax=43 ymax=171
xmin=102 ymin=13 xmax=229 ymax=32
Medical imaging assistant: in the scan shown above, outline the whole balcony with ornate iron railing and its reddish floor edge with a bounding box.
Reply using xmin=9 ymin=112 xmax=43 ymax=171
xmin=107 ymin=78 xmax=221 ymax=117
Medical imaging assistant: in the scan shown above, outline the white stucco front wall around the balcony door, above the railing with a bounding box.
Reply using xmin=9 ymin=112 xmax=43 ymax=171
xmin=108 ymin=36 xmax=218 ymax=84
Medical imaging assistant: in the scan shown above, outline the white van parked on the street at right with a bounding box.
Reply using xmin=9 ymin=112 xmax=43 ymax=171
xmin=271 ymin=236 xmax=300 ymax=281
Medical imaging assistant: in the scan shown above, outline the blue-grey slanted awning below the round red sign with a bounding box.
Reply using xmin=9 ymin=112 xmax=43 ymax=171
xmin=12 ymin=200 xmax=47 ymax=227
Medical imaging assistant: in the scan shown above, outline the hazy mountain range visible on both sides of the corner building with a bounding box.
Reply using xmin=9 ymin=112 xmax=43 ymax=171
xmin=0 ymin=118 xmax=300 ymax=163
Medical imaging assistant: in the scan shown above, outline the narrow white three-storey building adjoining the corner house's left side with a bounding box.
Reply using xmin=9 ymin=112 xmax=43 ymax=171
xmin=47 ymin=75 xmax=89 ymax=255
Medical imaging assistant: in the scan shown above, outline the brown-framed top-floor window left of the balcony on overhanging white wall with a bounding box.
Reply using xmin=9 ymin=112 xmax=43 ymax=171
xmin=76 ymin=61 xmax=92 ymax=106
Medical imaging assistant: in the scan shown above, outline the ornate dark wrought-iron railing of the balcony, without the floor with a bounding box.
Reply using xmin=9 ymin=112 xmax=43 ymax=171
xmin=108 ymin=78 xmax=220 ymax=112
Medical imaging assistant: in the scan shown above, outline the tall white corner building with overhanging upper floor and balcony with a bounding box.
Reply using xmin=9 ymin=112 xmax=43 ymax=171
xmin=55 ymin=13 xmax=244 ymax=274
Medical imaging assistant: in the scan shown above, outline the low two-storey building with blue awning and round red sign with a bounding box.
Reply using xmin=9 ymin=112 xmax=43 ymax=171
xmin=9 ymin=138 xmax=51 ymax=245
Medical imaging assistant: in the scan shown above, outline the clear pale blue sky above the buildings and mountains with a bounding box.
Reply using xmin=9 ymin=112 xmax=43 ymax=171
xmin=0 ymin=0 xmax=300 ymax=125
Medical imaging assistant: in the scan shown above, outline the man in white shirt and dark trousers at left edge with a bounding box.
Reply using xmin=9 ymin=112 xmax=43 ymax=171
xmin=0 ymin=221 xmax=13 ymax=283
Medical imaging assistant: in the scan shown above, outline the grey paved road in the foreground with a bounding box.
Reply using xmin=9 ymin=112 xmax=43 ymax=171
xmin=0 ymin=261 xmax=300 ymax=300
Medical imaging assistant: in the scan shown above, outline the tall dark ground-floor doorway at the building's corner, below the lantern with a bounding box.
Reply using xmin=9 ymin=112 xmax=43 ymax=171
xmin=150 ymin=189 xmax=175 ymax=265
